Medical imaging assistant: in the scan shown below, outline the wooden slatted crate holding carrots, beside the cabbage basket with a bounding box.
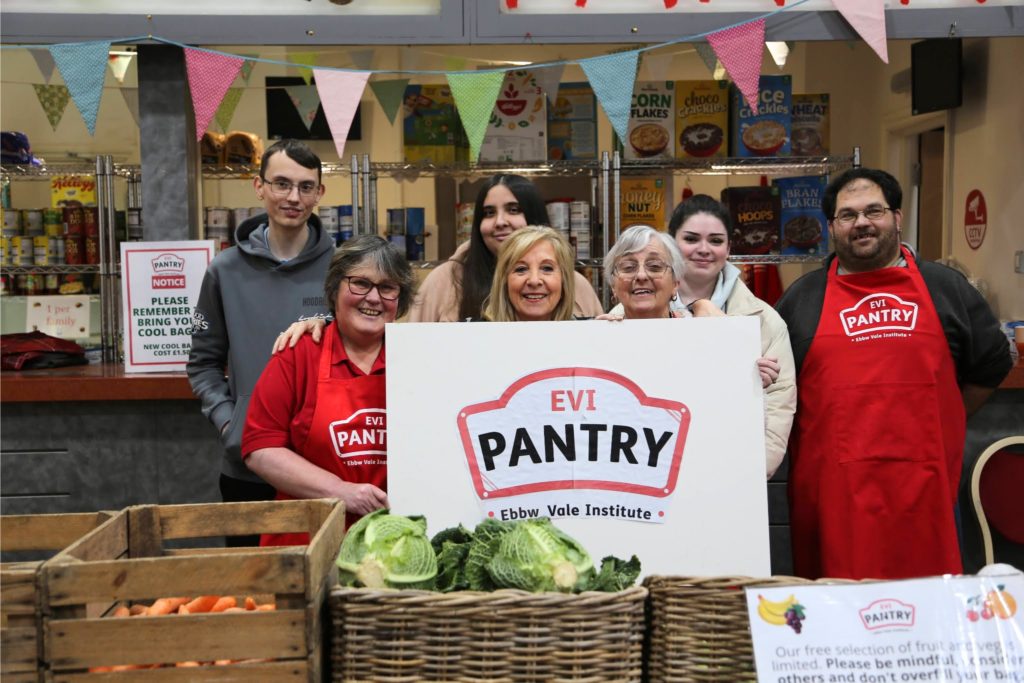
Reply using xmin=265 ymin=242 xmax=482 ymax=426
xmin=40 ymin=500 xmax=345 ymax=682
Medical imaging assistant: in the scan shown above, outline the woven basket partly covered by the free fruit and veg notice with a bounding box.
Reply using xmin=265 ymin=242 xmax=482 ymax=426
xmin=643 ymin=577 xmax=815 ymax=683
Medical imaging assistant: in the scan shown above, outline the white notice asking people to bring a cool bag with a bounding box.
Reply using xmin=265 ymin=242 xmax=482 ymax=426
xmin=121 ymin=240 xmax=214 ymax=373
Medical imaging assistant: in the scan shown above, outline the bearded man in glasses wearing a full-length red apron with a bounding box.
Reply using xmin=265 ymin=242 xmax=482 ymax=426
xmin=777 ymin=168 xmax=1011 ymax=579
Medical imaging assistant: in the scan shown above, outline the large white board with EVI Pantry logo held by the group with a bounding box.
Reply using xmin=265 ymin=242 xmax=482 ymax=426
xmin=386 ymin=317 xmax=770 ymax=575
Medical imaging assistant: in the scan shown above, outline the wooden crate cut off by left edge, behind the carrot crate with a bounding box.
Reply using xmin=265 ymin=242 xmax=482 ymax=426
xmin=0 ymin=512 xmax=112 ymax=683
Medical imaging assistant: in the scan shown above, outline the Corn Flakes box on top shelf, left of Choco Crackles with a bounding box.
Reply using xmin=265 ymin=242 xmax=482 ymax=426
xmin=623 ymin=81 xmax=676 ymax=159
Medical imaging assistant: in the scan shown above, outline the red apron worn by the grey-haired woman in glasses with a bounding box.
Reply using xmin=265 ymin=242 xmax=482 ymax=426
xmin=260 ymin=325 xmax=387 ymax=546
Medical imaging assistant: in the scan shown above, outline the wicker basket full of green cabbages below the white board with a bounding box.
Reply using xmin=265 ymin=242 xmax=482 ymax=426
xmin=330 ymin=587 xmax=647 ymax=683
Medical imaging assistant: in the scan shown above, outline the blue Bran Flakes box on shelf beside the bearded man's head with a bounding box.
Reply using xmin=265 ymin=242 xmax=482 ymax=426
xmin=773 ymin=175 xmax=828 ymax=256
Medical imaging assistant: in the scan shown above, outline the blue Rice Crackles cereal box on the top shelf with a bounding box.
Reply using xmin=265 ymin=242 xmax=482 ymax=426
xmin=731 ymin=76 xmax=793 ymax=157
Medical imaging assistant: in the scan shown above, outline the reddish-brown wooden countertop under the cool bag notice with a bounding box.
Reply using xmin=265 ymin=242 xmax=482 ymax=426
xmin=0 ymin=364 xmax=196 ymax=403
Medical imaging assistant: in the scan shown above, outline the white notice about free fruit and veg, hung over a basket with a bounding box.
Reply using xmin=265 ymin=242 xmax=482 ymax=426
xmin=746 ymin=573 xmax=1024 ymax=683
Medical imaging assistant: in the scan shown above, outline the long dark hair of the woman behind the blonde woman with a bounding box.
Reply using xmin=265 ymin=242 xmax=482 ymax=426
xmin=456 ymin=175 xmax=549 ymax=321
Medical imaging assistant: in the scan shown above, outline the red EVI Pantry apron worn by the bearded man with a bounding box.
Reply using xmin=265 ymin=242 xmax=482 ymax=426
xmin=790 ymin=251 xmax=966 ymax=579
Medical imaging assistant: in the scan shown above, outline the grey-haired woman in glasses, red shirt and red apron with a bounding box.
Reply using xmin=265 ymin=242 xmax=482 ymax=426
xmin=242 ymin=234 xmax=416 ymax=546
